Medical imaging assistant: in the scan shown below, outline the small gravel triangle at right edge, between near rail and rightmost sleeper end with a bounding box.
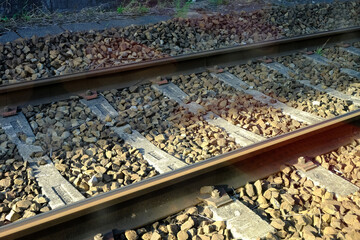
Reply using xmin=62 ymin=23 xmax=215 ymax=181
xmin=315 ymin=139 xmax=360 ymax=187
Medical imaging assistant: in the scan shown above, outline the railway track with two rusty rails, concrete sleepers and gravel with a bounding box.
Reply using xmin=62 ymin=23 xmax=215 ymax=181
xmin=0 ymin=28 xmax=360 ymax=239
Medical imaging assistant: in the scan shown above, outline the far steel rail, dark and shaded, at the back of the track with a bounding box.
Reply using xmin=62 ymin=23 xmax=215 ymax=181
xmin=0 ymin=27 xmax=360 ymax=107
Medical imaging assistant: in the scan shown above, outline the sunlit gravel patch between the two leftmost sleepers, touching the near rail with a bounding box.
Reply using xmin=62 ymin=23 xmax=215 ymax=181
xmin=52 ymin=138 xmax=158 ymax=197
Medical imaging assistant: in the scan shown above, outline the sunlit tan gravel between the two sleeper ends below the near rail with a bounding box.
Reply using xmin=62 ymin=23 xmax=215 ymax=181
xmin=236 ymin=163 xmax=360 ymax=240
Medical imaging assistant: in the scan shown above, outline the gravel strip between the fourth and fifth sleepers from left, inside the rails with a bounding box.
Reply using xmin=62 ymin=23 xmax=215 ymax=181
xmin=229 ymin=63 xmax=356 ymax=118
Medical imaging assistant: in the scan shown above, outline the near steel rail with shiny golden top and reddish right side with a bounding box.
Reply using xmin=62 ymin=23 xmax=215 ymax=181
xmin=0 ymin=110 xmax=360 ymax=240
